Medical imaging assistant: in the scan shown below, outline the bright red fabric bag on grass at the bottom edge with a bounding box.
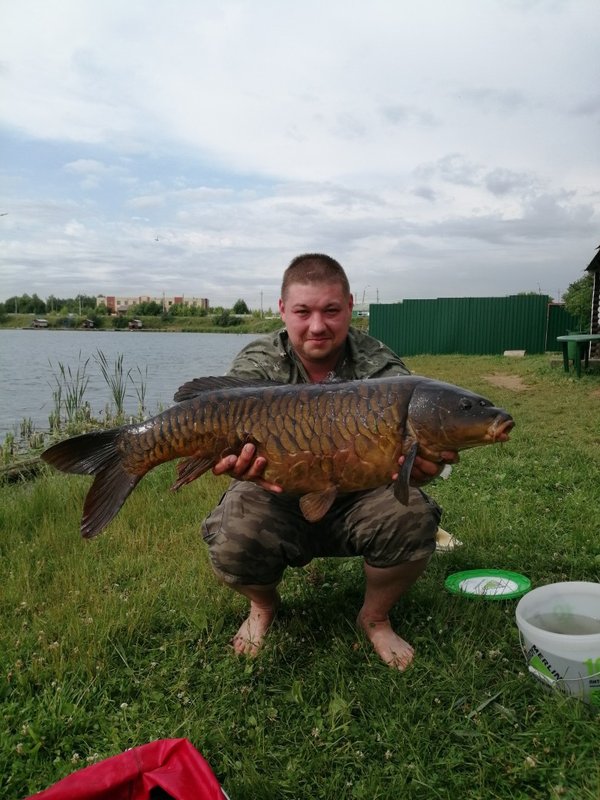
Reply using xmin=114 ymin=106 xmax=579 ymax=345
xmin=26 ymin=739 xmax=226 ymax=800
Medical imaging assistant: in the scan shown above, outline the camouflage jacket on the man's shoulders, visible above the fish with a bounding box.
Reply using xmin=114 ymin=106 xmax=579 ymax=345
xmin=227 ymin=328 xmax=410 ymax=383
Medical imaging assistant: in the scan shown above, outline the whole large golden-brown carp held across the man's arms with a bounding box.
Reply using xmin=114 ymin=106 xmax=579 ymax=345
xmin=42 ymin=375 xmax=514 ymax=537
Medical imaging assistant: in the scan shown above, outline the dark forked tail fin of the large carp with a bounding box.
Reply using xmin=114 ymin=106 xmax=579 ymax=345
xmin=42 ymin=428 xmax=145 ymax=539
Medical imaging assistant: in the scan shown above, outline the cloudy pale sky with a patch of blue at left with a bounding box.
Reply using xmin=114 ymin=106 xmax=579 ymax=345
xmin=0 ymin=0 xmax=600 ymax=309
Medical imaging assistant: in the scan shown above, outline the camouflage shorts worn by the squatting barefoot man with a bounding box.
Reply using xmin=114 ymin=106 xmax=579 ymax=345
xmin=202 ymin=481 xmax=441 ymax=585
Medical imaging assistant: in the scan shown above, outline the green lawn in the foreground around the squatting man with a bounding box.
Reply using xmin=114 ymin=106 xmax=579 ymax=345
xmin=0 ymin=356 xmax=600 ymax=800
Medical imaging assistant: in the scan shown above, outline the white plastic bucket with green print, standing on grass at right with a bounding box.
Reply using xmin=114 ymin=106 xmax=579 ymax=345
xmin=516 ymin=581 xmax=600 ymax=707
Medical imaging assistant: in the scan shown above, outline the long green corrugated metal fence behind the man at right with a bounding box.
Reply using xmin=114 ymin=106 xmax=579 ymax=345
xmin=369 ymin=295 xmax=556 ymax=356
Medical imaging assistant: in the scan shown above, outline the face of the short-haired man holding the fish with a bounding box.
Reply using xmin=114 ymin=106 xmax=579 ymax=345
xmin=279 ymin=282 xmax=352 ymax=362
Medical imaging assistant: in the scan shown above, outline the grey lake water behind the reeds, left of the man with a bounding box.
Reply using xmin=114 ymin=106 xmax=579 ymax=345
xmin=0 ymin=330 xmax=268 ymax=434
